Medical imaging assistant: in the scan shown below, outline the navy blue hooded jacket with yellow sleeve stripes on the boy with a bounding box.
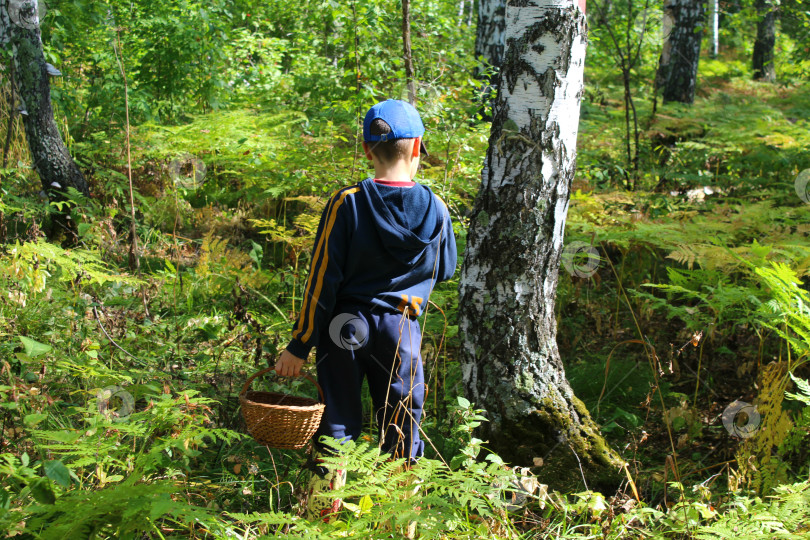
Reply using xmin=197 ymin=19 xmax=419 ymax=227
xmin=287 ymin=178 xmax=456 ymax=358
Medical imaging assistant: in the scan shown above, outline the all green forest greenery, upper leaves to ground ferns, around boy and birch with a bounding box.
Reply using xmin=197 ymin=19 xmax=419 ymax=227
xmin=0 ymin=0 xmax=810 ymax=538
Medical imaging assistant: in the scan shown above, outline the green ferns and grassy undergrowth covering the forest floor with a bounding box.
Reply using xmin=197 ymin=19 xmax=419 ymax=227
xmin=0 ymin=2 xmax=810 ymax=539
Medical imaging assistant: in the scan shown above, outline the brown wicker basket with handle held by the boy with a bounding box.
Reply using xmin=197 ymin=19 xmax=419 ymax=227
xmin=239 ymin=367 xmax=325 ymax=449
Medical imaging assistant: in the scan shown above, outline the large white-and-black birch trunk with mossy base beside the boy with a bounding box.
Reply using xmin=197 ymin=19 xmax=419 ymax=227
xmin=459 ymin=0 xmax=621 ymax=489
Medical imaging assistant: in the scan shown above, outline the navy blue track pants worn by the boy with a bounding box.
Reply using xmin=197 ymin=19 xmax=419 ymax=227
xmin=315 ymin=306 xmax=425 ymax=458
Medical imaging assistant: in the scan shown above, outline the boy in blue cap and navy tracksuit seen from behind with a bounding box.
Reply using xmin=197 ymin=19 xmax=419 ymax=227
xmin=275 ymin=99 xmax=456 ymax=519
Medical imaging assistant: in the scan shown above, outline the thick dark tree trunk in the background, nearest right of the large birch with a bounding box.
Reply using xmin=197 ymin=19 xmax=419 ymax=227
xmin=657 ymin=0 xmax=706 ymax=103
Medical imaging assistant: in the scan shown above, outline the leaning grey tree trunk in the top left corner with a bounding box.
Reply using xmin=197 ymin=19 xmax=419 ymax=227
xmin=0 ymin=0 xmax=90 ymax=205
